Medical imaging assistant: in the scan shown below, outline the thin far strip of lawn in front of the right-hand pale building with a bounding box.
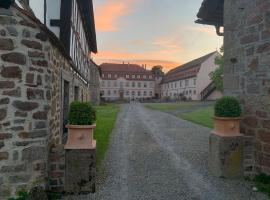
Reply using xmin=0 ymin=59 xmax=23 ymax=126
xmin=145 ymin=102 xmax=199 ymax=111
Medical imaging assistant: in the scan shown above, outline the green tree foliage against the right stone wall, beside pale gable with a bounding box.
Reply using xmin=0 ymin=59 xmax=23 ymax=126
xmin=209 ymin=47 xmax=224 ymax=92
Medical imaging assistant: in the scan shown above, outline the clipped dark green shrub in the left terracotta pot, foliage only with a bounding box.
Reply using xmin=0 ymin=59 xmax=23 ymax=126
xmin=68 ymin=101 xmax=96 ymax=125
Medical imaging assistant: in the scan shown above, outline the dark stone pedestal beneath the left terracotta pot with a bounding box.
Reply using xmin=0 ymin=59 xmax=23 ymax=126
xmin=65 ymin=149 xmax=96 ymax=193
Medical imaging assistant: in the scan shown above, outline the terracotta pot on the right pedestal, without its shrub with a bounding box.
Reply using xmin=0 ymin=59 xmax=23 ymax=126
xmin=213 ymin=117 xmax=241 ymax=136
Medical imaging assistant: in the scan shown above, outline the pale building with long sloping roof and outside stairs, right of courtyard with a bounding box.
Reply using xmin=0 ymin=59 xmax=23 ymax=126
xmin=161 ymin=52 xmax=222 ymax=100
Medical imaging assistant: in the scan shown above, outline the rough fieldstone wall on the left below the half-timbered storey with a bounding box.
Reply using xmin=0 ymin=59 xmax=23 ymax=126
xmin=0 ymin=5 xmax=99 ymax=199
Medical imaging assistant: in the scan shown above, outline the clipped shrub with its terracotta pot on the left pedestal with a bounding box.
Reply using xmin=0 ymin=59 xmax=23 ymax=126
xmin=65 ymin=101 xmax=96 ymax=149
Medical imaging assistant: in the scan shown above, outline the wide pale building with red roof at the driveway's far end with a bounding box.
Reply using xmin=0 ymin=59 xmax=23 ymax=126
xmin=100 ymin=63 xmax=155 ymax=101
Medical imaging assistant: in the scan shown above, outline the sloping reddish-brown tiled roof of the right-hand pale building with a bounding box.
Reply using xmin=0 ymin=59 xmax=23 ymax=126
xmin=162 ymin=51 xmax=217 ymax=83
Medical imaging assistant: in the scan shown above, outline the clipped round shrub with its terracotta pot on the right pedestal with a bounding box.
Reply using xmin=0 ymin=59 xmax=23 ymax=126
xmin=214 ymin=96 xmax=242 ymax=136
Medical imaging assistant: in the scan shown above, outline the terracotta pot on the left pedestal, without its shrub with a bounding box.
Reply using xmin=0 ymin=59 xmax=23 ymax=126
xmin=65 ymin=124 xmax=96 ymax=149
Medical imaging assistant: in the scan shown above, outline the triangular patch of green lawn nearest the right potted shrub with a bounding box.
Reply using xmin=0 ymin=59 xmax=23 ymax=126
xmin=178 ymin=106 xmax=214 ymax=128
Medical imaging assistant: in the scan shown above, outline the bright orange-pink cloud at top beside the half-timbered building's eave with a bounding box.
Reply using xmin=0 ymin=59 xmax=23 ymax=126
xmin=95 ymin=0 xmax=142 ymax=32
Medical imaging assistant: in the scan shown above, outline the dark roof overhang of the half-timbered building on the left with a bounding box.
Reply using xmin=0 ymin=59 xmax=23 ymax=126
xmin=77 ymin=0 xmax=97 ymax=53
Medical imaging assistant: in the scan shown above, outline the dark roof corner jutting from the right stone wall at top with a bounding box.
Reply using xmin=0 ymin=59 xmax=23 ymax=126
xmin=196 ymin=0 xmax=224 ymax=27
